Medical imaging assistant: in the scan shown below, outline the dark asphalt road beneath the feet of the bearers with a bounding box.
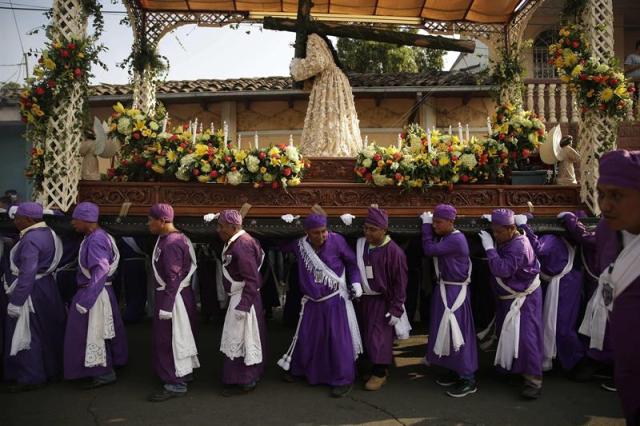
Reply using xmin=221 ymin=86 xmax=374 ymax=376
xmin=0 ymin=320 xmax=624 ymax=426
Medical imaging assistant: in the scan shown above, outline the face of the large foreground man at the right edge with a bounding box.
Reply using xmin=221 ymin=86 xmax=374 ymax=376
xmin=598 ymin=185 xmax=640 ymax=234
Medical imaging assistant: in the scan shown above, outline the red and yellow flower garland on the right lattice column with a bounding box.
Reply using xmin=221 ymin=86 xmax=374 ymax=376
xmin=549 ymin=24 xmax=635 ymax=120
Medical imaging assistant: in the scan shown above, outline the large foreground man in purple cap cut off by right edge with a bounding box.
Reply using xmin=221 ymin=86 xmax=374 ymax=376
xmin=597 ymin=150 xmax=640 ymax=426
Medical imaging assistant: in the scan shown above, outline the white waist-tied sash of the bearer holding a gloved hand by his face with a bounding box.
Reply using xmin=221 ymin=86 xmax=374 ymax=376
xmin=493 ymin=275 xmax=540 ymax=370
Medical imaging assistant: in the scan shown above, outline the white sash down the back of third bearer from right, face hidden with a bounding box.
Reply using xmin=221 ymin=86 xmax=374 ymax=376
xmin=541 ymin=238 xmax=576 ymax=371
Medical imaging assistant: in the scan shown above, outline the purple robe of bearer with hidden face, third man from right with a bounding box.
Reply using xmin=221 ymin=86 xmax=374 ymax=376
xmin=522 ymin=224 xmax=586 ymax=370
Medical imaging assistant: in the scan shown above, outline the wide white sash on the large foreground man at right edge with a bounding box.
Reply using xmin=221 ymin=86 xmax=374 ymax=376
xmin=579 ymin=236 xmax=640 ymax=350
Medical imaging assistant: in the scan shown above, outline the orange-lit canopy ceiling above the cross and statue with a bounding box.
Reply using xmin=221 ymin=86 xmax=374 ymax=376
xmin=138 ymin=0 xmax=532 ymax=24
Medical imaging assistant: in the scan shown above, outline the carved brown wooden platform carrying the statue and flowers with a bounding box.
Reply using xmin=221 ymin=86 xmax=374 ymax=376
xmin=78 ymin=158 xmax=583 ymax=217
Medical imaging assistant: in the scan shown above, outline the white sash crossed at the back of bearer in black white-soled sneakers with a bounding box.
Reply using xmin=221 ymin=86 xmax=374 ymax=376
xmin=433 ymin=257 xmax=471 ymax=357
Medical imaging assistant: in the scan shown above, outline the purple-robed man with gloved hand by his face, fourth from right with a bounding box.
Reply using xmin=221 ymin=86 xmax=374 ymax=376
xmin=480 ymin=209 xmax=543 ymax=399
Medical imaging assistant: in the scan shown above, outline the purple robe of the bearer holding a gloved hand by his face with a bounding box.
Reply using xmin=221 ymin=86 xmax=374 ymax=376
xmin=487 ymin=235 xmax=544 ymax=377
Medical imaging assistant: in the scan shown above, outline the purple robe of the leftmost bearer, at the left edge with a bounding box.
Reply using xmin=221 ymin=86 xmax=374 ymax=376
xmin=3 ymin=228 xmax=66 ymax=384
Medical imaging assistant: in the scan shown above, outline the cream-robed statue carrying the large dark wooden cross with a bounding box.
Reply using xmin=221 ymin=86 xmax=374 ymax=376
xmin=290 ymin=34 xmax=362 ymax=157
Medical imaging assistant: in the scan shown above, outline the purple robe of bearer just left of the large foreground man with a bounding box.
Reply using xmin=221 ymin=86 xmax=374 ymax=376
xmin=564 ymin=215 xmax=622 ymax=364
